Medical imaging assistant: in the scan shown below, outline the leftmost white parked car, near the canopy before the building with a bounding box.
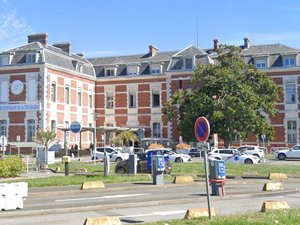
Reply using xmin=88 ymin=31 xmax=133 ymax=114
xmin=91 ymin=147 xmax=129 ymax=162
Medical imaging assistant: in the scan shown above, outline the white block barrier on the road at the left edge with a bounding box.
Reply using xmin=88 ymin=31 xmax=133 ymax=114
xmin=0 ymin=182 xmax=28 ymax=210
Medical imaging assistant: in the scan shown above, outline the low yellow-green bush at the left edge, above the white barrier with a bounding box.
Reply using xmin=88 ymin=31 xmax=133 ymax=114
xmin=0 ymin=157 xmax=25 ymax=177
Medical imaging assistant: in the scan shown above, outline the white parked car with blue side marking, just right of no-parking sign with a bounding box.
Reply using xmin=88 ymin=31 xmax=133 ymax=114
xmin=208 ymin=149 xmax=260 ymax=164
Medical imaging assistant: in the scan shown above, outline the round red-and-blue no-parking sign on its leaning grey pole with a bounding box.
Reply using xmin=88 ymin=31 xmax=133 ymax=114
xmin=194 ymin=117 xmax=212 ymax=220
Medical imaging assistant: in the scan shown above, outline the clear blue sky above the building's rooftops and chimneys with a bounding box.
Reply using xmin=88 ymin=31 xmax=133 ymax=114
xmin=0 ymin=0 xmax=300 ymax=57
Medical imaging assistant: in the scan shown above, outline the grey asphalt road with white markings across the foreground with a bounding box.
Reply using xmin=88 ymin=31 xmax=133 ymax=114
xmin=0 ymin=178 xmax=300 ymax=225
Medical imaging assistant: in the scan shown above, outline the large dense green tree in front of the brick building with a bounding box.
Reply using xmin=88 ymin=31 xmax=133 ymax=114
xmin=166 ymin=46 xmax=282 ymax=147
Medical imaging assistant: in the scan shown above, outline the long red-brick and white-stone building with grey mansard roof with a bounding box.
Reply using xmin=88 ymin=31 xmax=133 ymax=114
xmin=0 ymin=34 xmax=300 ymax=153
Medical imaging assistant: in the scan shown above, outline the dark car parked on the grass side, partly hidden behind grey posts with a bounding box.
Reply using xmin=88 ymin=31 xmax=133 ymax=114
xmin=115 ymin=153 xmax=172 ymax=174
